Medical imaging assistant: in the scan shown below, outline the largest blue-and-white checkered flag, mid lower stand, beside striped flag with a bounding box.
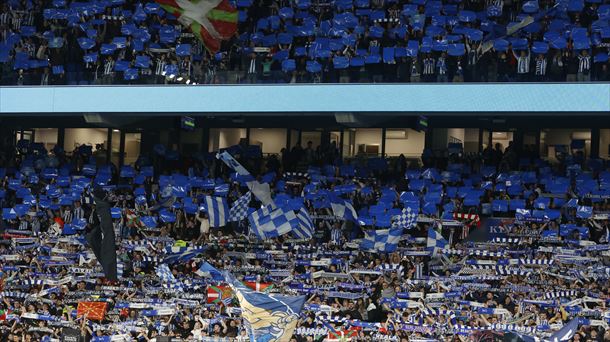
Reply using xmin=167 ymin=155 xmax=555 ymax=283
xmin=248 ymin=207 xmax=297 ymax=240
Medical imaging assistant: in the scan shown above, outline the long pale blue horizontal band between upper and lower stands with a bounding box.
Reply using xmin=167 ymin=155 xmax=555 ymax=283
xmin=0 ymin=83 xmax=610 ymax=115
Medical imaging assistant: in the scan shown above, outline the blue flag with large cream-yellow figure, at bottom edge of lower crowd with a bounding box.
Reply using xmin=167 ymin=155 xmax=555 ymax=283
xmin=225 ymin=273 xmax=306 ymax=342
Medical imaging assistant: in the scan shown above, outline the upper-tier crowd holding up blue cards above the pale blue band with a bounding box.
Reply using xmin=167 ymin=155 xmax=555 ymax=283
xmin=0 ymin=0 xmax=610 ymax=85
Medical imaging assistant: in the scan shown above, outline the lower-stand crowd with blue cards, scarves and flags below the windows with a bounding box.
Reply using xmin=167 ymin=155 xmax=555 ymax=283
xmin=0 ymin=138 xmax=610 ymax=342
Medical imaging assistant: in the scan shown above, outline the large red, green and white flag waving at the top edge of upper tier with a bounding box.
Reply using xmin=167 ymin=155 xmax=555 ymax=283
xmin=156 ymin=0 xmax=237 ymax=53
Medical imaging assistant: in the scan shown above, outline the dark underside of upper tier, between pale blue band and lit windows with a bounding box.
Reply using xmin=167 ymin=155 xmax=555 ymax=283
xmin=0 ymin=113 xmax=610 ymax=131
